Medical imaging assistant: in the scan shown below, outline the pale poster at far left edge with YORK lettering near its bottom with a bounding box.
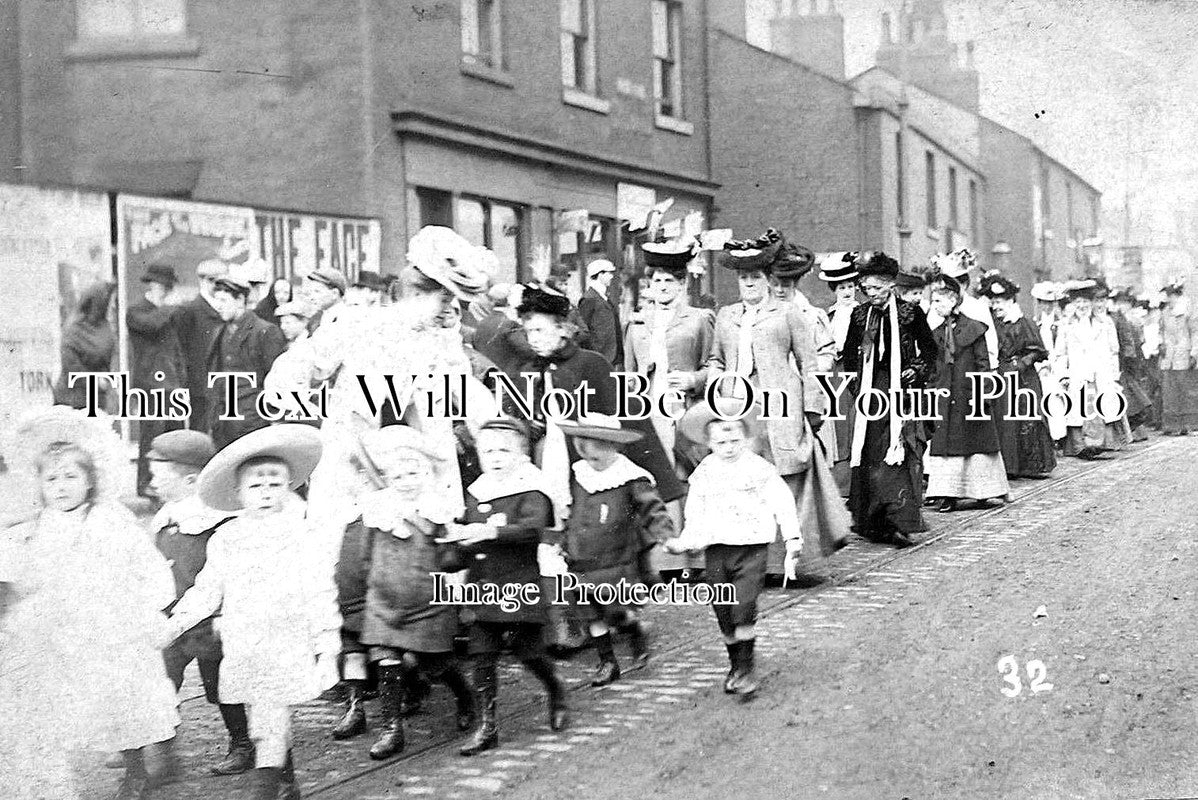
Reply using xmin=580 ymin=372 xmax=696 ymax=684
xmin=0 ymin=184 xmax=113 ymax=440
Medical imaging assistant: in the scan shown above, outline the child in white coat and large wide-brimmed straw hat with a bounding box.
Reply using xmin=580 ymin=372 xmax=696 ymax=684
xmin=160 ymin=424 xmax=341 ymax=800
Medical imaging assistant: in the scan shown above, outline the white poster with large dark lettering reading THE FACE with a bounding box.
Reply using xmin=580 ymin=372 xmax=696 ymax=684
xmin=254 ymin=211 xmax=382 ymax=284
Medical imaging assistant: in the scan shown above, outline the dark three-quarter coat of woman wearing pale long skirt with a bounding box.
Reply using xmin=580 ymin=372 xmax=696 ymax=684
xmin=928 ymin=314 xmax=999 ymax=456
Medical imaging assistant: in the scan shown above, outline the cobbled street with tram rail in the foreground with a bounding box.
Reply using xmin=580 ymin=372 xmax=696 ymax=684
xmin=70 ymin=440 xmax=1198 ymax=800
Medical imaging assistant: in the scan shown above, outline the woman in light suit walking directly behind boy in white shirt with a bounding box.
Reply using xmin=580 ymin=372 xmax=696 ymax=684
xmin=708 ymin=230 xmax=852 ymax=571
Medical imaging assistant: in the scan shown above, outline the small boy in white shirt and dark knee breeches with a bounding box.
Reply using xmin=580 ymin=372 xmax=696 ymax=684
xmin=665 ymin=398 xmax=803 ymax=699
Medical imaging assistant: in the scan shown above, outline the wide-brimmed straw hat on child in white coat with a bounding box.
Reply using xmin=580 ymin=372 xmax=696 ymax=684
xmin=199 ymin=424 xmax=322 ymax=511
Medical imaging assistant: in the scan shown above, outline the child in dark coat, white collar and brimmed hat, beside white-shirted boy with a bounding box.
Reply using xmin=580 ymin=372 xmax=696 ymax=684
xmin=561 ymin=414 xmax=676 ymax=686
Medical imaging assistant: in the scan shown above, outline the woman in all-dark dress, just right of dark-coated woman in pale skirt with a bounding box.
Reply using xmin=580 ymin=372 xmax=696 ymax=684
xmin=981 ymin=274 xmax=1057 ymax=478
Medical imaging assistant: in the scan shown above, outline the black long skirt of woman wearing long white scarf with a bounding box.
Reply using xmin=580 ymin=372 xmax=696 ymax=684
xmin=848 ymin=418 xmax=927 ymax=535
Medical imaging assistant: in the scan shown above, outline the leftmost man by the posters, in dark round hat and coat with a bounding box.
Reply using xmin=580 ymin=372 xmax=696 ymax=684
xmin=125 ymin=263 xmax=187 ymax=495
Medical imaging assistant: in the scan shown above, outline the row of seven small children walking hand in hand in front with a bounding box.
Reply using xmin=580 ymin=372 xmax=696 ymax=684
xmin=0 ymin=392 xmax=801 ymax=800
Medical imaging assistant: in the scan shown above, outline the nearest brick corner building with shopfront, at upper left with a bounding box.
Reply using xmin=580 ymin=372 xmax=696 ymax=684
xmin=0 ymin=0 xmax=715 ymax=297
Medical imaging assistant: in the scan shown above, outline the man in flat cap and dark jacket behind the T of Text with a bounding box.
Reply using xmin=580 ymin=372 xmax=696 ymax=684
xmin=207 ymin=275 xmax=288 ymax=449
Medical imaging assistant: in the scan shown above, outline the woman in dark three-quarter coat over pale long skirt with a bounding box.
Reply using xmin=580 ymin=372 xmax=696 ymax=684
xmin=926 ymin=275 xmax=1010 ymax=511
